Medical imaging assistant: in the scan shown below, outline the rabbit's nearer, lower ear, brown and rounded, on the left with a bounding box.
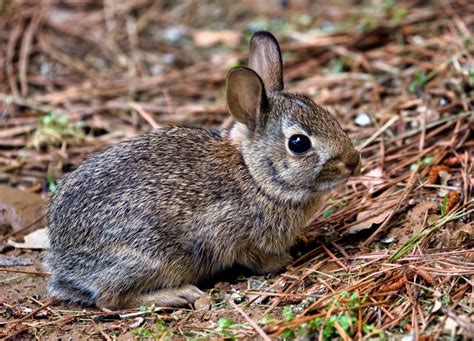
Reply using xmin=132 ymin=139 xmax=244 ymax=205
xmin=226 ymin=67 xmax=268 ymax=130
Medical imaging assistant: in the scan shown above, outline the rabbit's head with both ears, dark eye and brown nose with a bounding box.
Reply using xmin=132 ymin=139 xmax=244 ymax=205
xmin=227 ymin=32 xmax=360 ymax=201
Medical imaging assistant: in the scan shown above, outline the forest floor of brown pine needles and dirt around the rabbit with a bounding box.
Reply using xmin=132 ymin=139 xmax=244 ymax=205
xmin=0 ymin=0 xmax=474 ymax=340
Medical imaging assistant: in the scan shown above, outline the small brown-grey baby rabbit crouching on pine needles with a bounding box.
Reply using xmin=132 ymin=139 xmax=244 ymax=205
xmin=46 ymin=32 xmax=360 ymax=307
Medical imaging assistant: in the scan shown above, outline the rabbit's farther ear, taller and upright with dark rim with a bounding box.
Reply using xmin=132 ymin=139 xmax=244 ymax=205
xmin=249 ymin=31 xmax=283 ymax=92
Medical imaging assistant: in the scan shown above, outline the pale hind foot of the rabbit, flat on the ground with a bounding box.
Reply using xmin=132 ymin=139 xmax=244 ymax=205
xmin=139 ymin=285 xmax=205 ymax=307
